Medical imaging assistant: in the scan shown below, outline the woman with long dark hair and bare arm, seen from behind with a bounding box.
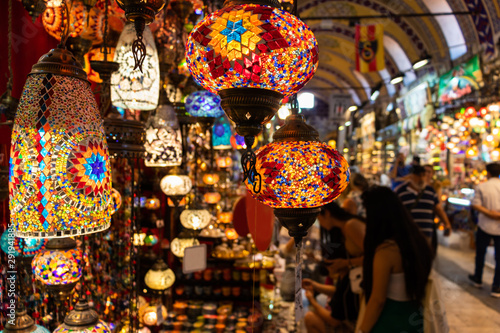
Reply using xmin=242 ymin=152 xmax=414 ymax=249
xmin=359 ymin=186 xmax=432 ymax=333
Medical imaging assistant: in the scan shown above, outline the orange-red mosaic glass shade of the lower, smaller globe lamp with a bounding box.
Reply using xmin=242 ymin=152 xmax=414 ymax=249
xmin=245 ymin=141 xmax=350 ymax=208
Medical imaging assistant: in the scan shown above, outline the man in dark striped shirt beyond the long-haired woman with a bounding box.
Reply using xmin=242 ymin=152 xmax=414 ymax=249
xmin=396 ymin=165 xmax=451 ymax=242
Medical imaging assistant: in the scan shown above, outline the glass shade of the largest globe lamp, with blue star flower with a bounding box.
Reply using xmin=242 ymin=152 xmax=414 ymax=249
xmin=186 ymin=4 xmax=318 ymax=96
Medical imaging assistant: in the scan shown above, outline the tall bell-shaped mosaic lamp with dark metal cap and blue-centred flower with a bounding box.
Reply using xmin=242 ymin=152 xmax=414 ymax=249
xmin=9 ymin=47 xmax=111 ymax=238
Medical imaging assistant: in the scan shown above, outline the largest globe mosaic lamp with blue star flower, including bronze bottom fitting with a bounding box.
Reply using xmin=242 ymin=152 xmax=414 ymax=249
xmin=186 ymin=0 xmax=318 ymax=139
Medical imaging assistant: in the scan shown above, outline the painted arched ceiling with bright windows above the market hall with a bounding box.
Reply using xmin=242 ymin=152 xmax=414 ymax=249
xmin=298 ymin=0 xmax=500 ymax=103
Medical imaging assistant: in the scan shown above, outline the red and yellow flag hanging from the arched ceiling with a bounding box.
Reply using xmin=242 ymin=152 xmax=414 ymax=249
xmin=356 ymin=24 xmax=385 ymax=73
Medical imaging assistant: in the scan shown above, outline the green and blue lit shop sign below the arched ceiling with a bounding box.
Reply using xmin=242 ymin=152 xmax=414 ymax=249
xmin=438 ymin=55 xmax=483 ymax=104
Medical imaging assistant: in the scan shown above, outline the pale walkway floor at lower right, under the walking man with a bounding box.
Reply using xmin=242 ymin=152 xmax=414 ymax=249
xmin=435 ymin=247 xmax=500 ymax=333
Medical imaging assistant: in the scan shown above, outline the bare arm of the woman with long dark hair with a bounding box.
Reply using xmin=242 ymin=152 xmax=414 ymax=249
xmin=359 ymin=247 xmax=392 ymax=333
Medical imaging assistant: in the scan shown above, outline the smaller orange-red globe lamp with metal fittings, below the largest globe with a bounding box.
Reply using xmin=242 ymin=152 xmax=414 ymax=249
xmin=245 ymin=114 xmax=350 ymax=243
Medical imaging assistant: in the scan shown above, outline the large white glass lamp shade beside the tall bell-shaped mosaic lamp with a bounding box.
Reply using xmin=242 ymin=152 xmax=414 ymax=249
xmin=111 ymin=23 xmax=160 ymax=110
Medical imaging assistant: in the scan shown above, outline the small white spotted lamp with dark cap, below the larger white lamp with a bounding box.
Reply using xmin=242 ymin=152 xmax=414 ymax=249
xmin=144 ymin=89 xmax=182 ymax=167
